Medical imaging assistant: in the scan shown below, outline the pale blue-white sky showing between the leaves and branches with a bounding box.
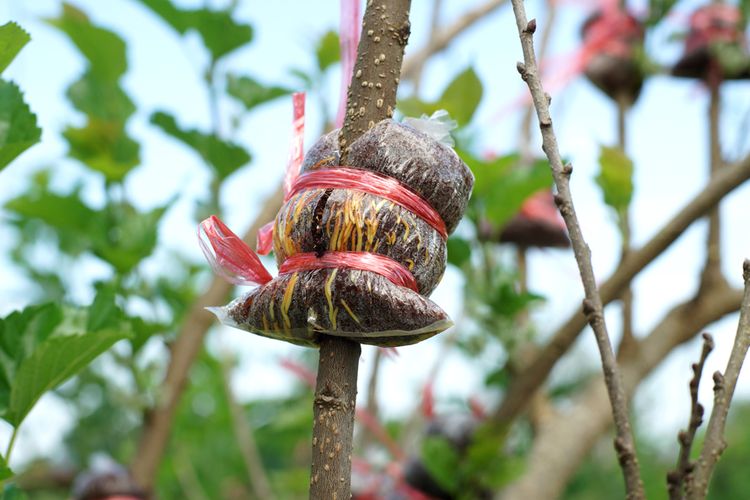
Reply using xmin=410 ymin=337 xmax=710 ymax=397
xmin=0 ymin=0 xmax=750 ymax=468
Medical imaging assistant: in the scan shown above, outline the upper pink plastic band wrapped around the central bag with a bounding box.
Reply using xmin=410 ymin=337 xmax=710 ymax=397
xmin=286 ymin=167 xmax=448 ymax=239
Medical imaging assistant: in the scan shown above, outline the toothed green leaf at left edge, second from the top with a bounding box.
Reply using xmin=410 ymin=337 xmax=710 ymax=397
xmin=0 ymin=80 xmax=42 ymax=170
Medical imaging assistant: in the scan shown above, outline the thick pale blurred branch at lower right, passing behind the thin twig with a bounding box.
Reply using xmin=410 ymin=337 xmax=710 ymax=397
xmin=502 ymin=286 xmax=742 ymax=500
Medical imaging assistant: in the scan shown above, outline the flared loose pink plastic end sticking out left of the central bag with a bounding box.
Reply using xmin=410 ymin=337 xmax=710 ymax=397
xmin=198 ymin=215 xmax=273 ymax=285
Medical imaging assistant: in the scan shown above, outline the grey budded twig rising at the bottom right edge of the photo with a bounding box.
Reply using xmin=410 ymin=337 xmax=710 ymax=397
xmin=687 ymin=260 xmax=750 ymax=500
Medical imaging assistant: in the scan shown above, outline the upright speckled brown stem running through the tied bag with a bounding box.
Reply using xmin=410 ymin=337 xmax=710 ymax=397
xmin=310 ymin=0 xmax=411 ymax=500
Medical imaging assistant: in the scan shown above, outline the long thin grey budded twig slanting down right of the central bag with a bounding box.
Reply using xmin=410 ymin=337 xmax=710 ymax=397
xmin=511 ymin=5 xmax=644 ymax=499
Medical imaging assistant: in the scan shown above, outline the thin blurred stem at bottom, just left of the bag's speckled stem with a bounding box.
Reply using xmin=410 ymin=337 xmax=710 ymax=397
xmin=221 ymin=359 xmax=275 ymax=500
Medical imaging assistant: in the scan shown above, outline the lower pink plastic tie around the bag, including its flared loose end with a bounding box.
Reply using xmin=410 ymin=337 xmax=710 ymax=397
xmin=198 ymin=215 xmax=418 ymax=292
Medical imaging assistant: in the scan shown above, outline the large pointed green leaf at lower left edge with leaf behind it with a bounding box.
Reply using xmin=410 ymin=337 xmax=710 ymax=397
xmin=0 ymin=295 xmax=131 ymax=427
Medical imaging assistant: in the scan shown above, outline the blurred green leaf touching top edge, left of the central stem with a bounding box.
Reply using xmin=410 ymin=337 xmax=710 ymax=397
xmin=139 ymin=0 xmax=253 ymax=61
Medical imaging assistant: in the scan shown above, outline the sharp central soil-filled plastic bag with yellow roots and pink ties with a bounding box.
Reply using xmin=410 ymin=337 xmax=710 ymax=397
xmin=200 ymin=97 xmax=474 ymax=346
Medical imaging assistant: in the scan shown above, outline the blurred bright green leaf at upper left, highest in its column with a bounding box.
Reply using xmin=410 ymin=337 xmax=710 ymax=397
xmin=47 ymin=3 xmax=128 ymax=81
